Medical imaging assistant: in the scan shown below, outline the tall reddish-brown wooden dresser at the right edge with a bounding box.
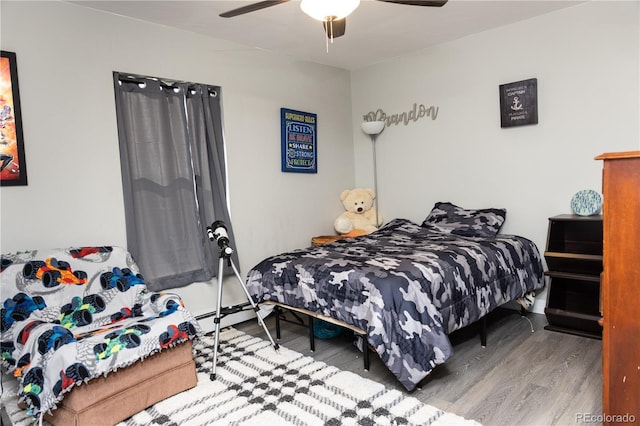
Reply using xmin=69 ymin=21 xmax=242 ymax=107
xmin=596 ymin=151 xmax=640 ymax=425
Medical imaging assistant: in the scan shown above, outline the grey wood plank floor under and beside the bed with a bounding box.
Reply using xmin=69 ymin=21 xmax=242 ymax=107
xmin=234 ymin=309 xmax=602 ymax=426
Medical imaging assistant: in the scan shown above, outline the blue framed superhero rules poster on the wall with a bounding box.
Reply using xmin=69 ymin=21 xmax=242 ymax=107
xmin=280 ymin=108 xmax=318 ymax=173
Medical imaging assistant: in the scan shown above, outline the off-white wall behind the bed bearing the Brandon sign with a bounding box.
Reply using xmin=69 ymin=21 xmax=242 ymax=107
xmin=351 ymin=1 xmax=640 ymax=312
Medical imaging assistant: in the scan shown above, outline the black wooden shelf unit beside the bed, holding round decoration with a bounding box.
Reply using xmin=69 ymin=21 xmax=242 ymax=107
xmin=544 ymin=215 xmax=602 ymax=339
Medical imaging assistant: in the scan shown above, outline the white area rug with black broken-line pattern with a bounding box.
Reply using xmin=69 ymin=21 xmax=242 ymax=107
xmin=3 ymin=328 xmax=479 ymax=426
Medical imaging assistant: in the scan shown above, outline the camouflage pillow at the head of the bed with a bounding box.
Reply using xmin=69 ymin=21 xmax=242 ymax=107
xmin=422 ymin=203 xmax=507 ymax=238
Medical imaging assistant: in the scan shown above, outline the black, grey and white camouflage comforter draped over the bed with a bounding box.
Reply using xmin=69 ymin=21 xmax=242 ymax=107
xmin=247 ymin=219 xmax=544 ymax=390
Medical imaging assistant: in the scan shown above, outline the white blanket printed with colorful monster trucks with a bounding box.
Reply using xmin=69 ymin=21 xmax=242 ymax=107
xmin=0 ymin=247 xmax=200 ymax=416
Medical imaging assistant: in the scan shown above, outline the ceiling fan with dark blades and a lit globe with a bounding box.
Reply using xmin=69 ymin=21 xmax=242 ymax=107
xmin=220 ymin=0 xmax=448 ymax=41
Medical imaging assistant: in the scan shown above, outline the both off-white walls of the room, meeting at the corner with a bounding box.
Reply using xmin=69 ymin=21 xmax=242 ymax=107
xmin=0 ymin=0 xmax=640 ymax=321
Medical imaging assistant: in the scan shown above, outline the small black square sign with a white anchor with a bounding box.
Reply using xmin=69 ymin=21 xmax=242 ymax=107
xmin=500 ymin=78 xmax=538 ymax=127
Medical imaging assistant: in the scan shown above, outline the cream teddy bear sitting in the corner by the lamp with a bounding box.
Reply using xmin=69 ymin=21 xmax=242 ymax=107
xmin=333 ymin=188 xmax=382 ymax=236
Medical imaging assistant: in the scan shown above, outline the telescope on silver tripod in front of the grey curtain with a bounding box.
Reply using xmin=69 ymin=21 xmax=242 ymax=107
xmin=209 ymin=240 xmax=280 ymax=381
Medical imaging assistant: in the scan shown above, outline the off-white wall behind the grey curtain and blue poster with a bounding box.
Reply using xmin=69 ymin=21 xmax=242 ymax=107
xmin=0 ymin=0 xmax=354 ymax=330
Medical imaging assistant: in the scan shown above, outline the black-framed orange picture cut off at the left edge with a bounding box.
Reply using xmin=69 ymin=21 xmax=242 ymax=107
xmin=0 ymin=50 xmax=27 ymax=186
